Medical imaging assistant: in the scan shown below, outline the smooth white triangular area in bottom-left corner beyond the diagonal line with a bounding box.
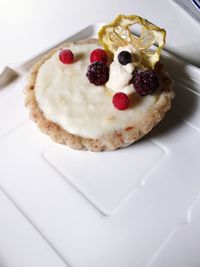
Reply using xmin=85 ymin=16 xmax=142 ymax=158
xmin=0 ymin=187 xmax=66 ymax=267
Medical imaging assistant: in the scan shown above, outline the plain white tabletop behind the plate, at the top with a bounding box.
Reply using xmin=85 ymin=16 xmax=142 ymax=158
xmin=0 ymin=0 xmax=200 ymax=66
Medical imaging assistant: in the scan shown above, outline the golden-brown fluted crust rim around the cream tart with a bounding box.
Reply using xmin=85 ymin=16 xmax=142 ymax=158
xmin=24 ymin=39 xmax=175 ymax=152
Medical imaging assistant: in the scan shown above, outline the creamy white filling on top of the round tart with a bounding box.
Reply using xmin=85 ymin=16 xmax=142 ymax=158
xmin=35 ymin=44 xmax=157 ymax=138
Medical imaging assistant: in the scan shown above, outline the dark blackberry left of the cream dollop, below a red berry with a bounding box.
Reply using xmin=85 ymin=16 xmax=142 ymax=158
xmin=86 ymin=62 xmax=108 ymax=85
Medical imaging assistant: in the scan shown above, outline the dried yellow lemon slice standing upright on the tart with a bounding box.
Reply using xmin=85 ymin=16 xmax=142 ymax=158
xmin=99 ymin=15 xmax=166 ymax=68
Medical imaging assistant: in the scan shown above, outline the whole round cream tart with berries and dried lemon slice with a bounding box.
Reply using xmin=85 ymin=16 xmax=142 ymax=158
xmin=25 ymin=15 xmax=174 ymax=151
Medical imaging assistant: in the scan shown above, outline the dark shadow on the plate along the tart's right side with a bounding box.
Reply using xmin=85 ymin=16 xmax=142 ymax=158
xmin=141 ymin=57 xmax=199 ymax=142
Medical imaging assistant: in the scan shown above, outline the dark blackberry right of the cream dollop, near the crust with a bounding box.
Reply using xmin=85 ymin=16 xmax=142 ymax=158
xmin=132 ymin=70 xmax=159 ymax=96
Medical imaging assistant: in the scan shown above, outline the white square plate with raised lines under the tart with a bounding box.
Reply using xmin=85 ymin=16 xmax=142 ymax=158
xmin=0 ymin=25 xmax=200 ymax=267
